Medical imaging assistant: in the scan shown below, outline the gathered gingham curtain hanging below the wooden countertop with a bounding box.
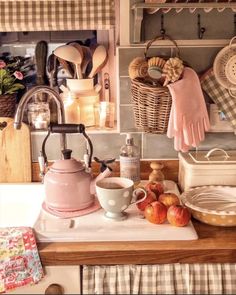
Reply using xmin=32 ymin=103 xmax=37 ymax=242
xmin=82 ymin=263 xmax=236 ymax=294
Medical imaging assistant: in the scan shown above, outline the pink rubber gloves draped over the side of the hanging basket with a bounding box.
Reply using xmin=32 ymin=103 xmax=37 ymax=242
xmin=167 ymin=67 xmax=210 ymax=147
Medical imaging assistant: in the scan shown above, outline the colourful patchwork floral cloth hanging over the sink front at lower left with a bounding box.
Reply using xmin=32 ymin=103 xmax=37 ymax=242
xmin=0 ymin=227 xmax=44 ymax=293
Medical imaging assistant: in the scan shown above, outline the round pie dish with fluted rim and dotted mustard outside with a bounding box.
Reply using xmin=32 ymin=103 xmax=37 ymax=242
xmin=180 ymin=186 xmax=236 ymax=227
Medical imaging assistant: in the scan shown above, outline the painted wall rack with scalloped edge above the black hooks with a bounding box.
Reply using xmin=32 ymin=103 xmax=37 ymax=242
xmin=131 ymin=2 xmax=236 ymax=43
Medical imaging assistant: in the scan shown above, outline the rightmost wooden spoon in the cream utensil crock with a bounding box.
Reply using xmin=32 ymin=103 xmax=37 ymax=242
xmin=88 ymin=45 xmax=108 ymax=78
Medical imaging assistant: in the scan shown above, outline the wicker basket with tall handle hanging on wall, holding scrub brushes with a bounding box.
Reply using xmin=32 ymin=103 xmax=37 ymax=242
xmin=131 ymin=36 xmax=179 ymax=134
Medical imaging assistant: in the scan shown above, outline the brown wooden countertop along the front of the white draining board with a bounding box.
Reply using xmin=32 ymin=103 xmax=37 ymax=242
xmin=38 ymin=220 xmax=236 ymax=266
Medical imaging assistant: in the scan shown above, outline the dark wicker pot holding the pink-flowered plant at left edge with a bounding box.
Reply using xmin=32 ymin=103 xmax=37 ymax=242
xmin=0 ymin=94 xmax=16 ymax=118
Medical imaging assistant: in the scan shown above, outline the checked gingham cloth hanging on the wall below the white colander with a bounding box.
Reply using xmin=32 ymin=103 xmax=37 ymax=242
xmin=200 ymin=68 xmax=236 ymax=131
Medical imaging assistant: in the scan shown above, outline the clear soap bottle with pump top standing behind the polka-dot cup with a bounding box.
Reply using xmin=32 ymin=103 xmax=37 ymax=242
xmin=120 ymin=133 xmax=140 ymax=185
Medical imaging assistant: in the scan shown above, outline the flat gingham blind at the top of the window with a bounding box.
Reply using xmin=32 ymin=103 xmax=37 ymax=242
xmin=0 ymin=0 xmax=114 ymax=32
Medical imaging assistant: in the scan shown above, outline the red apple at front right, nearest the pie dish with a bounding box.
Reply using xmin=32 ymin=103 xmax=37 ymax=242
xmin=167 ymin=205 xmax=191 ymax=226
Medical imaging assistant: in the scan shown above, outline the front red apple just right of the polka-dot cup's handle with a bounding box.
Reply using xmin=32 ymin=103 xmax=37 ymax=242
xmin=144 ymin=201 xmax=167 ymax=224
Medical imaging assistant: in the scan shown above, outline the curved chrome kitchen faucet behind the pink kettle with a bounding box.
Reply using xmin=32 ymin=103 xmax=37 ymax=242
xmin=14 ymin=85 xmax=66 ymax=150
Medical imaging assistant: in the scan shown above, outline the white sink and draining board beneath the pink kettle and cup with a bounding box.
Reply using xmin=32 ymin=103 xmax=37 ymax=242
xmin=0 ymin=180 xmax=198 ymax=242
